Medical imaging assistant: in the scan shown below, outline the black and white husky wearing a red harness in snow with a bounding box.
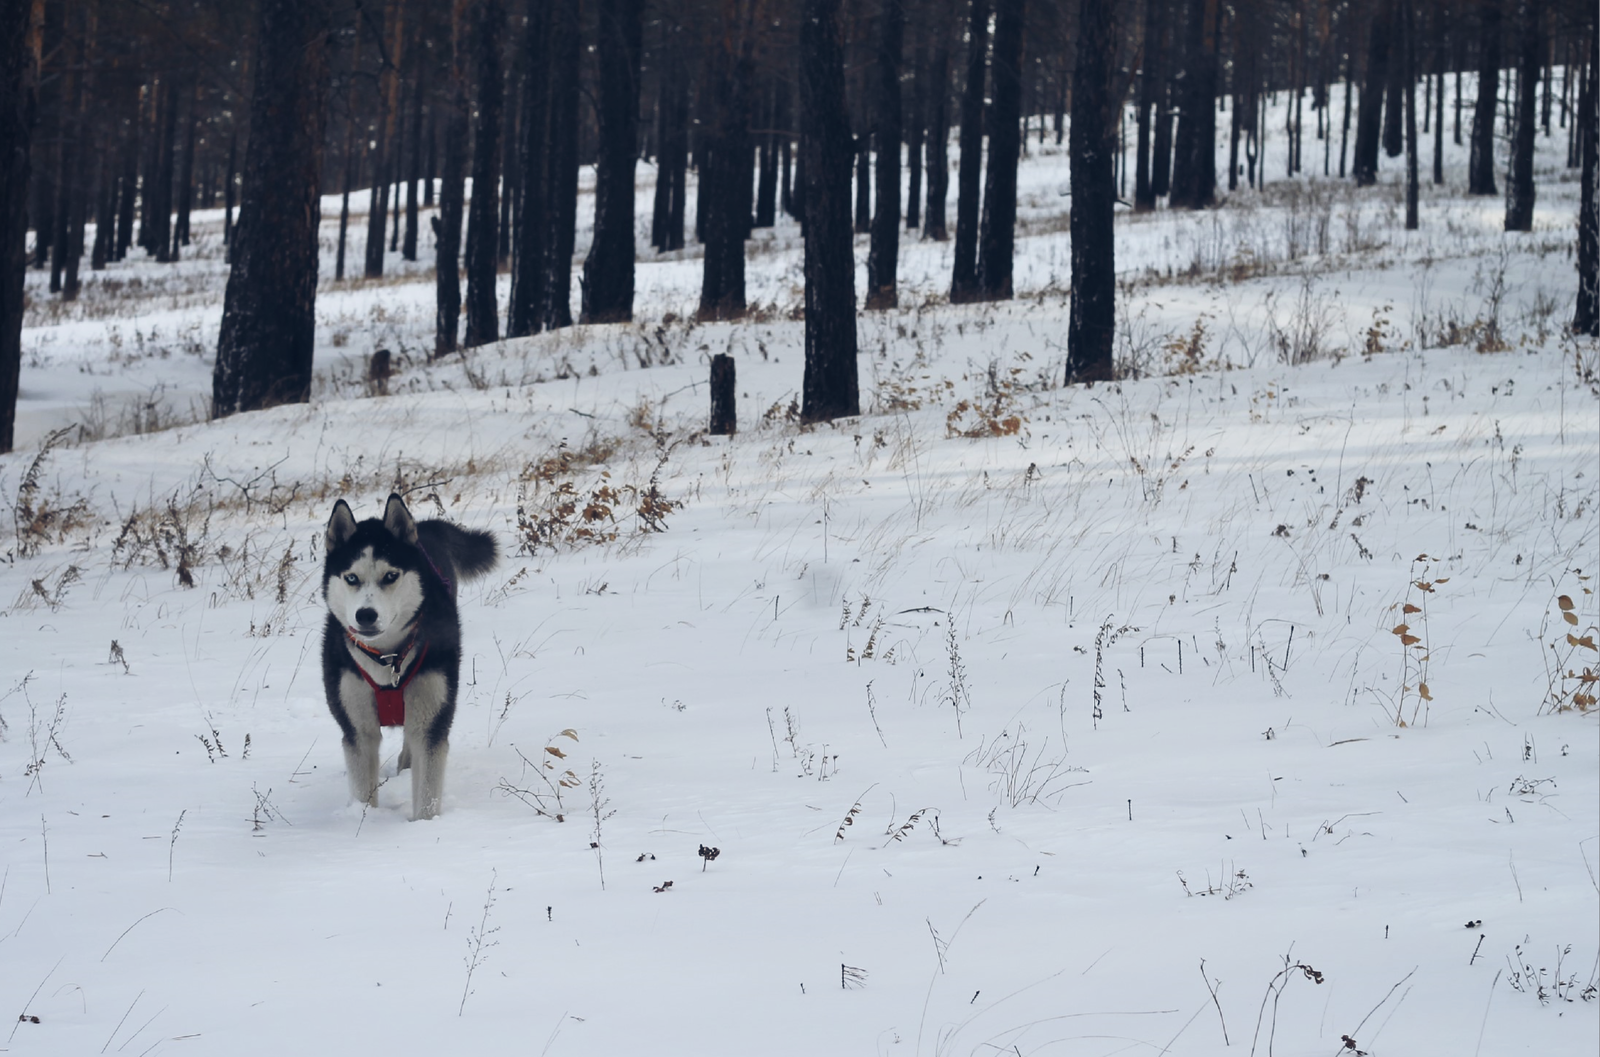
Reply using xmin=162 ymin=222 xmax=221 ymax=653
xmin=322 ymin=494 xmax=494 ymax=819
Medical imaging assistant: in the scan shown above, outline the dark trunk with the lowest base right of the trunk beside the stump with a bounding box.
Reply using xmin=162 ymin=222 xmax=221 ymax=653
xmin=1068 ymin=0 xmax=1120 ymax=384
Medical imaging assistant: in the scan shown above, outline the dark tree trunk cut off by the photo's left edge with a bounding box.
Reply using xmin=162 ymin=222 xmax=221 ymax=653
xmin=0 ymin=0 xmax=43 ymax=454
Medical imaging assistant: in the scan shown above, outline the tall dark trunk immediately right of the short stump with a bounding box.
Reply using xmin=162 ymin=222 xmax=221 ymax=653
xmin=800 ymin=0 xmax=861 ymax=422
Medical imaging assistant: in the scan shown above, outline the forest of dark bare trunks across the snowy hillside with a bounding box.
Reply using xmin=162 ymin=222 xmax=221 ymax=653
xmin=0 ymin=0 xmax=1600 ymax=449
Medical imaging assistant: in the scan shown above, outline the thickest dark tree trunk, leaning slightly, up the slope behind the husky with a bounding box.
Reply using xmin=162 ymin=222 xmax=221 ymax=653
xmin=211 ymin=0 xmax=328 ymax=417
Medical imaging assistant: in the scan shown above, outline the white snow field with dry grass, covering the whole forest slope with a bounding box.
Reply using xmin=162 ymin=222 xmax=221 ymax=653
xmin=0 ymin=82 xmax=1600 ymax=1057
